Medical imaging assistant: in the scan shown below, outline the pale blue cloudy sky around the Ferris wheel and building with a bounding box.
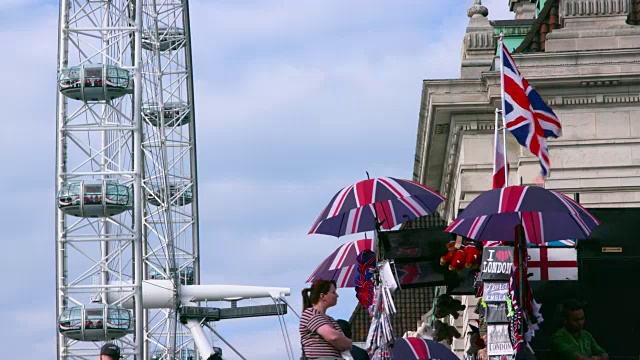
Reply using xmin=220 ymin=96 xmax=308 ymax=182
xmin=0 ymin=0 xmax=513 ymax=360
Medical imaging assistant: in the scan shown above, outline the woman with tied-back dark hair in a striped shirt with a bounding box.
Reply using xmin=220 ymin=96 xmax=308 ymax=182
xmin=299 ymin=280 xmax=351 ymax=360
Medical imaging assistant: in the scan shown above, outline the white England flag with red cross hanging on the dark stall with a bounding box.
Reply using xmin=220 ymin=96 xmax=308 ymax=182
xmin=527 ymin=247 xmax=578 ymax=281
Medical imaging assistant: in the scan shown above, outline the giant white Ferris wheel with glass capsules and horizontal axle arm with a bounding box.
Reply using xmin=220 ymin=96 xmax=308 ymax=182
xmin=56 ymin=0 xmax=289 ymax=360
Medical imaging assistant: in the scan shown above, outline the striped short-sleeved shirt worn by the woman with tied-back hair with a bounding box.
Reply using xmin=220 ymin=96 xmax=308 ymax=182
xmin=299 ymin=307 xmax=342 ymax=360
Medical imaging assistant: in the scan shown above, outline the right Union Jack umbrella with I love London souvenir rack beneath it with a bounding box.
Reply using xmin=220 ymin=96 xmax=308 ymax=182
xmin=445 ymin=186 xmax=599 ymax=360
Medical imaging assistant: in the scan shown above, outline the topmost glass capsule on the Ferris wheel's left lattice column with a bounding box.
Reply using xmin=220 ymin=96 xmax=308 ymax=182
xmin=58 ymin=64 xmax=133 ymax=102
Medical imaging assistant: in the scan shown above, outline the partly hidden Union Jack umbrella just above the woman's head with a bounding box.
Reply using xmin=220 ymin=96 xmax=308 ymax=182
xmin=307 ymin=239 xmax=372 ymax=288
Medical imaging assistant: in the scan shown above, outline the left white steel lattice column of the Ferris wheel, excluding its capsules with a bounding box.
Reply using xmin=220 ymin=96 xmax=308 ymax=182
xmin=56 ymin=0 xmax=144 ymax=359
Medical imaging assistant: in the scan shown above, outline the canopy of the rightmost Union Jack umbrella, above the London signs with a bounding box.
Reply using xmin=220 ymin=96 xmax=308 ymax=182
xmin=445 ymin=186 xmax=600 ymax=245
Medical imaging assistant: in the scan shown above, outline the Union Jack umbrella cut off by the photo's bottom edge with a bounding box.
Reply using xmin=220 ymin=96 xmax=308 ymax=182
xmin=391 ymin=337 xmax=460 ymax=360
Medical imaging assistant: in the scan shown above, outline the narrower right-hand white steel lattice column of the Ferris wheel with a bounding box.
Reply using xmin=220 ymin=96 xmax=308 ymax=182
xmin=142 ymin=0 xmax=200 ymax=360
